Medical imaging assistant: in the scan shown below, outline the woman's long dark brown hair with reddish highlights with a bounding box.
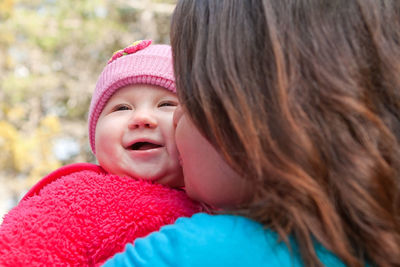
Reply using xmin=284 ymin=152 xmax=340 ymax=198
xmin=171 ymin=0 xmax=400 ymax=266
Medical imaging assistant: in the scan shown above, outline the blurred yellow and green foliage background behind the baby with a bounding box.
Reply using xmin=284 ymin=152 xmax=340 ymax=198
xmin=0 ymin=0 xmax=176 ymax=222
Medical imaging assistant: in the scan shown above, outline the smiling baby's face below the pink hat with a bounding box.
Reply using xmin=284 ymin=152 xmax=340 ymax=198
xmin=95 ymin=84 xmax=183 ymax=187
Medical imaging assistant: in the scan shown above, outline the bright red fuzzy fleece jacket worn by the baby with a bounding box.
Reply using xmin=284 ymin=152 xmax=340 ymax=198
xmin=0 ymin=163 xmax=201 ymax=266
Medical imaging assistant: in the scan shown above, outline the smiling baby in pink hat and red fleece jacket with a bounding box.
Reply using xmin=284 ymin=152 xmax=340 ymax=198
xmin=0 ymin=40 xmax=202 ymax=266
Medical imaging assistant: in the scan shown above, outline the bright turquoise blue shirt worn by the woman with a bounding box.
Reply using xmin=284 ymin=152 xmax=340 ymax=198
xmin=104 ymin=213 xmax=345 ymax=267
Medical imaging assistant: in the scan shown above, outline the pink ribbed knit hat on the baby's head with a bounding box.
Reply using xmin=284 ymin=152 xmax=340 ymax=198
xmin=89 ymin=40 xmax=176 ymax=154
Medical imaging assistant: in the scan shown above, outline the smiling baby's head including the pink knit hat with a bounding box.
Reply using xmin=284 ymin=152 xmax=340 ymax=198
xmin=89 ymin=41 xmax=183 ymax=187
